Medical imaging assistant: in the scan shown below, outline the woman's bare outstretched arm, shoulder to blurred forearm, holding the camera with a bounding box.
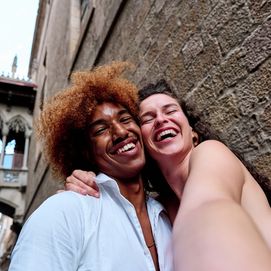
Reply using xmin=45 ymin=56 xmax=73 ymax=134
xmin=173 ymin=141 xmax=271 ymax=271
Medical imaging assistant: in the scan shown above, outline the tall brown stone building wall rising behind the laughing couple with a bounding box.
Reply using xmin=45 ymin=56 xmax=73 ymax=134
xmin=25 ymin=0 xmax=271 ymax=218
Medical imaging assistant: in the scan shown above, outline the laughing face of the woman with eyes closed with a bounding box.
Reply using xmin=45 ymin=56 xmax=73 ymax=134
xmin=139 ymin=94 xmax=193 ymax=164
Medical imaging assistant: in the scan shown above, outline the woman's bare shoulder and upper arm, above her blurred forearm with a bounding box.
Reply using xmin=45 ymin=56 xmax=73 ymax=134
xmin=185 ymin=140 xmax=245 ymax=206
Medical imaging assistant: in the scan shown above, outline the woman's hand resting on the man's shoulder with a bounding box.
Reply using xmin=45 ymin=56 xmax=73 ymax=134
xmin=65 ymin=169 xmax=100 ymax=198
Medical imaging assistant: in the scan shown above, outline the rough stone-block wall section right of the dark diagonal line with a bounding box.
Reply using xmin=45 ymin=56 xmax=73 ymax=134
xmin=94 ymin=0 xmax=271 ymax=180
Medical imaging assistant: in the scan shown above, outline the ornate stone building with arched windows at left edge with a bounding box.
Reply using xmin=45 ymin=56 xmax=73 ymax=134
xmin=0 ymin=75 xmax=36 ymax=270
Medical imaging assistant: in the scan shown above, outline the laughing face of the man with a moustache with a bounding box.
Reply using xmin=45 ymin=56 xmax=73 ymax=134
xmin=89 ymin=102 xmax=145 ymax=180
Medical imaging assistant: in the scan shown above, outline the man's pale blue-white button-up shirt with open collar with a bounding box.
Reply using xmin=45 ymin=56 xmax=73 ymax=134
xmin=9 ymin=174 xmax=173 ymax=271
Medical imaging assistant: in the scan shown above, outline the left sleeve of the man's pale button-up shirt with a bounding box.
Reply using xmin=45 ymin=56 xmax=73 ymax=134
xmin=9 ymin=192 xmax=85 ymax=271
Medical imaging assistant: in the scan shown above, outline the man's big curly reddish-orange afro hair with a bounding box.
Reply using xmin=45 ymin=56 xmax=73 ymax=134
xmin=36 ymin=62 xmax=138 ymax=181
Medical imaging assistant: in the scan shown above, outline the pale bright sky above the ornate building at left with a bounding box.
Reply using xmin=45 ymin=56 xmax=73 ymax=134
xmin=0 ymin=0 xmax=39 ymax=80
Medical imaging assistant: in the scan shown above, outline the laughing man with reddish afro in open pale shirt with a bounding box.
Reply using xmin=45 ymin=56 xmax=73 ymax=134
xmin=9 ymin=62 xmax=173 ymax=271
